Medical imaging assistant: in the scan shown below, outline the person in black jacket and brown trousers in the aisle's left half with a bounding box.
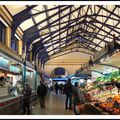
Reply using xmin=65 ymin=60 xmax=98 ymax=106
xmin=37 ymin=80 xmax=47 ymax=108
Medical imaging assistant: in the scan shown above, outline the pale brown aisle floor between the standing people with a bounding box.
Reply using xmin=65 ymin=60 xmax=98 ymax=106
xmin=33 ymin=92 xmax=74 ymax=115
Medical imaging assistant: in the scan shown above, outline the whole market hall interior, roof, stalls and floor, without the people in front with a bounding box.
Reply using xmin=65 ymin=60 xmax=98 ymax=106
xmin=0 ymin=3 xmax=120 ymax=115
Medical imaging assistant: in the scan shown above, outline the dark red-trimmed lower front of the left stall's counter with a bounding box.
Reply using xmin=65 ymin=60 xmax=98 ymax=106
xmin=0 ymin=92 xmax=37 ymax=115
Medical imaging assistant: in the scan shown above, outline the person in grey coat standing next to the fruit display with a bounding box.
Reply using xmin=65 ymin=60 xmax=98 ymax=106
xmin=73 ymin=82 xmax=85 ymax=114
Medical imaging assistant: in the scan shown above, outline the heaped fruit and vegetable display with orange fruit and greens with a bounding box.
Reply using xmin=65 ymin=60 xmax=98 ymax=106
xmin=85 ymin=72 xmax=120 ymax=115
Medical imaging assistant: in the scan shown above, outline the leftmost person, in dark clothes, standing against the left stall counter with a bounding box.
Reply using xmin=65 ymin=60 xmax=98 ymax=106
xmin=23 ymin=83 xmax=32 ymax=115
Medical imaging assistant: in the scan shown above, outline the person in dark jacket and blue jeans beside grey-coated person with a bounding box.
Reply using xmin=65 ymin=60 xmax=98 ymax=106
xmin=64 ymin=78 xmax=73 ymax=110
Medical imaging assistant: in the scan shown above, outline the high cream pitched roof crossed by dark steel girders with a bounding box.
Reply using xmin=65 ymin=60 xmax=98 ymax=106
xmin=5 ymin=5 xmax=120 ymax=63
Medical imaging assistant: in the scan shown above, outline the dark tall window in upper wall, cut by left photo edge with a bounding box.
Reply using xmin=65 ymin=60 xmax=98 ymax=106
xmin=0 ymin=21 xmax=6 ymax=43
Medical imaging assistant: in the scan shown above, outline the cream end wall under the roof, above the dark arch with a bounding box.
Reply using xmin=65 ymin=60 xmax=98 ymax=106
xmin=44 ymin=52 xmax=90 ymax=74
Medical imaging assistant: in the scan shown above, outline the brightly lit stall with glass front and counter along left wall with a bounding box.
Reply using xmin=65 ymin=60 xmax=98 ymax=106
xmin=0 ymin=51 xmax=37 ymax=115
